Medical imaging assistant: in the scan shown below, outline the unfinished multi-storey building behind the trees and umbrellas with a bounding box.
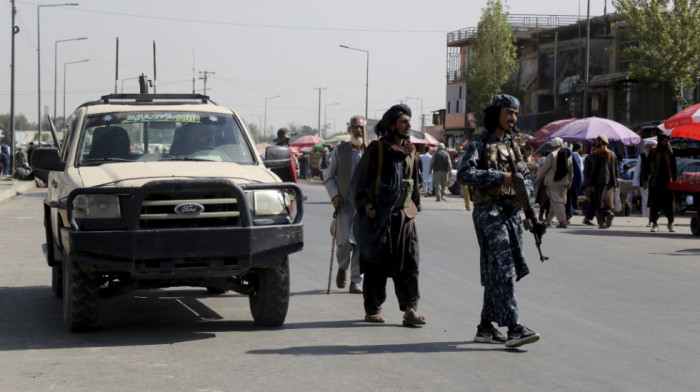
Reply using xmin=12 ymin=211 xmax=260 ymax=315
xmin=443 ymin=14 xmax=693 ymax=139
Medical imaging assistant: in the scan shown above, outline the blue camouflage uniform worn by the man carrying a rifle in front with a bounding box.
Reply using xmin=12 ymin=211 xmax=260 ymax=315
xmin=457 ymin=131 xmax=532 ymax=327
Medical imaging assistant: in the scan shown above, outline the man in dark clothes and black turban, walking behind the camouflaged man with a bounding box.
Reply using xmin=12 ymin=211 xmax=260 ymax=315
xmin=353 ymin=104 xmax=426 ymax=327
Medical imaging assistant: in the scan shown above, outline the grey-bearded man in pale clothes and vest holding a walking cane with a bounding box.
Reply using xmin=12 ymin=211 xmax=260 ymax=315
xmin=323 ymin=116 xmax=365 ymax=294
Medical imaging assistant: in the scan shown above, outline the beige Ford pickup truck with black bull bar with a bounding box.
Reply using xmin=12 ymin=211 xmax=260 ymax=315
xmin=31 ymin=94 xmax=303 ymax=331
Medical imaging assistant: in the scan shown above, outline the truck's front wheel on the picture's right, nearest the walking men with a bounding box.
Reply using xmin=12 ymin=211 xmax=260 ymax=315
xmin=248 ymin=257 xmax=289 ymax=327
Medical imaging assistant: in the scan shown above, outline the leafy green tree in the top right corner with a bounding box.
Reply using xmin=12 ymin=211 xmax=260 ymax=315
xmin=613 ymin=0 xmax=700 ymax=107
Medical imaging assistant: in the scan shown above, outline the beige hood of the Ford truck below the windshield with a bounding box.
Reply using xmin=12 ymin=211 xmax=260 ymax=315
xmin=78 ymin=161 xmax=280 ymax=188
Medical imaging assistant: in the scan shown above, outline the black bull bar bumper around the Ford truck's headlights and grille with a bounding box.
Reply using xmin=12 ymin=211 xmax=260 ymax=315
xmin=55 ymin=180 xmax=304 ymax=277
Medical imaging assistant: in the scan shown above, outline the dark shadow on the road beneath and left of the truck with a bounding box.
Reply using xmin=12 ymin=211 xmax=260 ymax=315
xmin=0 ymin=286 xmax=260 ymax=352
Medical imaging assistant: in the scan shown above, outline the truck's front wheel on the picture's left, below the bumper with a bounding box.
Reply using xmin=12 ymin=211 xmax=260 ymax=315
xmin=63 ymin=252 xmax=100 ymax=332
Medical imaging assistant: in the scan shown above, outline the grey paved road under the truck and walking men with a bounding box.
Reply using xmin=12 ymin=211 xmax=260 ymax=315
xmin=0 ymin=184 xmax=700 ymax=391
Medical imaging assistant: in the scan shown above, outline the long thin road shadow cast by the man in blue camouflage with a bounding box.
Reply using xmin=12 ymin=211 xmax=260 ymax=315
xmin=247 ymin=342 xmax=526 ymax=356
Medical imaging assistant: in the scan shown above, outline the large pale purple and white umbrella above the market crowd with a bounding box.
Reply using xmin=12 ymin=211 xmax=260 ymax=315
xmin=549 ymin=117 xmax=642 ymax=146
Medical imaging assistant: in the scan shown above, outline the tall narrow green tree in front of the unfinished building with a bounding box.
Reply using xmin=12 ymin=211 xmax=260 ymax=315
xmin=465 ymin=0 xmax=518 ymax=122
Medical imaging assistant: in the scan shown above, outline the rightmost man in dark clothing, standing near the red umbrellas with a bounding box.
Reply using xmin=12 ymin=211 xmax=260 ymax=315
xmin=641 ymin=133 xmax=678 ymax=233
